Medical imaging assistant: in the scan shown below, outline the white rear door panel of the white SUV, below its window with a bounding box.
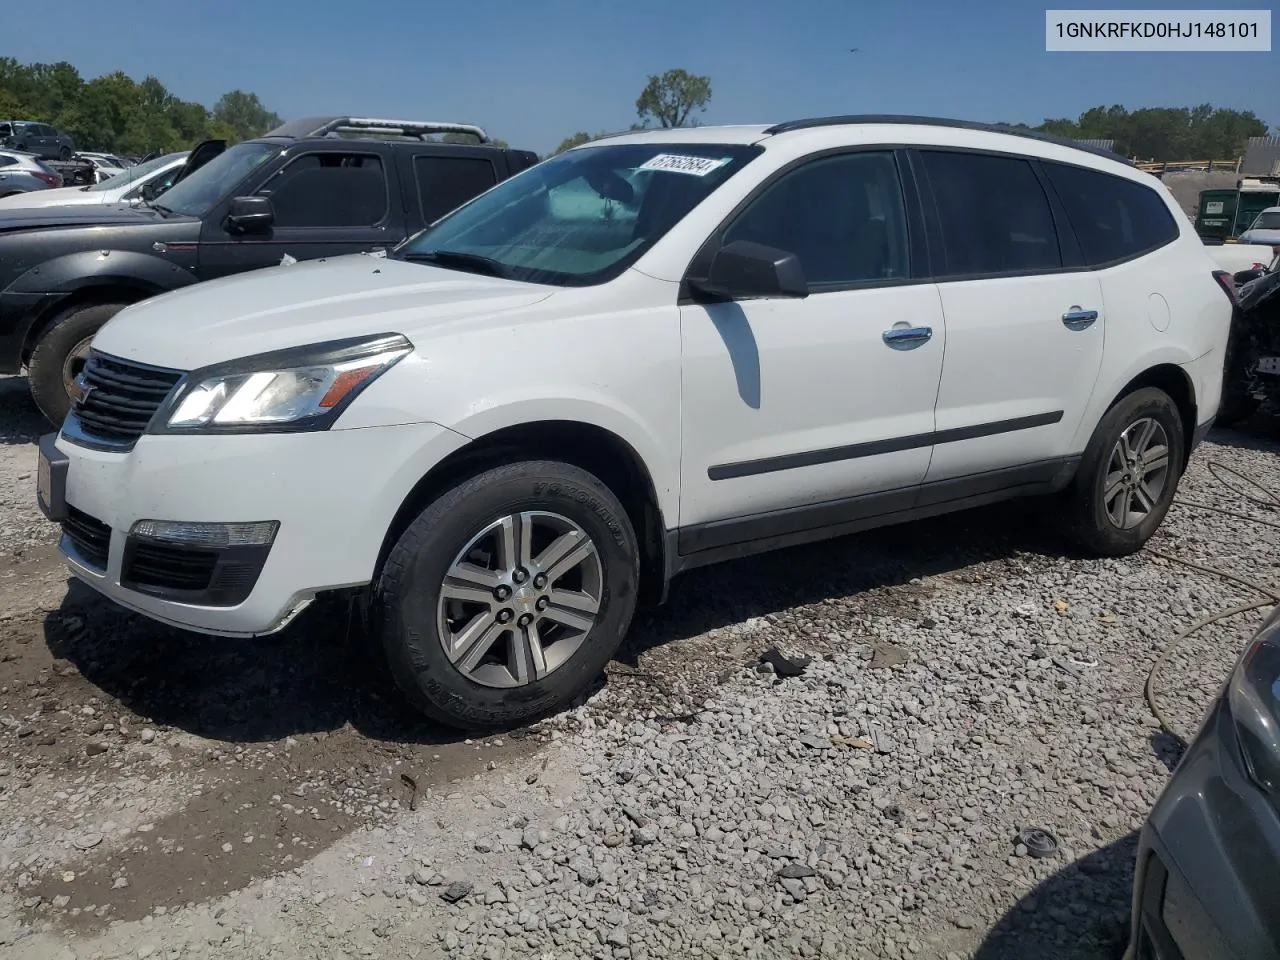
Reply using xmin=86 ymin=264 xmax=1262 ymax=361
xmin=925 ymin=273 xmax=1106 ymax=483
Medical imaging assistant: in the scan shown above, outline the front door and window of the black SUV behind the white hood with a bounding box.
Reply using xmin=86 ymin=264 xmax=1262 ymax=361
xmin=200 ymin=141 xmax=404 ymax=279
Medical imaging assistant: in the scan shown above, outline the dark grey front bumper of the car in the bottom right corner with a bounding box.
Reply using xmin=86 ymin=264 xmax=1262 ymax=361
xmin=1129 ymin=700 xmax=1280 ymax=960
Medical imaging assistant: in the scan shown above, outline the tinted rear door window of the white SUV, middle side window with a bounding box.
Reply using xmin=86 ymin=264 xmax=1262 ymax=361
xmin=920 ymin=150 xmax=1062 ymax=279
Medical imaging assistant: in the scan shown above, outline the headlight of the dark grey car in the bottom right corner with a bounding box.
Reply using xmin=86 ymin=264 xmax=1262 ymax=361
xmin=1228 ymin=608 xmax=1280 ymax=796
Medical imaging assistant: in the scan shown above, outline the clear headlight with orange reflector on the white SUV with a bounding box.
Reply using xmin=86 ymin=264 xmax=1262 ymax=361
xmin=154 ymin=334 xmax=413 ymax=434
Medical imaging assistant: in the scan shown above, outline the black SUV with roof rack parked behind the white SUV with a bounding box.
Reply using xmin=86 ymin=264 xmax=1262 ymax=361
xmin=0 ymin=116 xmax=538 ymax=422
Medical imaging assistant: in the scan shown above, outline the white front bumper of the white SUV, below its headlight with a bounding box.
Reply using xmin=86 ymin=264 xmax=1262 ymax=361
xmin=44 ymin=424 xmax=467 ymax=636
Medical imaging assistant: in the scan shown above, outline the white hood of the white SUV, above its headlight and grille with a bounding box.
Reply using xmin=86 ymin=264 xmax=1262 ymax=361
xmin=93 ymin=253 xmax=556 ymax=370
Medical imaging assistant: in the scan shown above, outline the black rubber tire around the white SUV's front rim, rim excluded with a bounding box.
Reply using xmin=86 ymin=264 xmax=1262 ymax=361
xmin=372 ymin=461 xmax=640 ymax=730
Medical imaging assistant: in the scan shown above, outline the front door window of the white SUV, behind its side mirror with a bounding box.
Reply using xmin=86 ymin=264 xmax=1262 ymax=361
xmin=724 ymin=152 xmax=910 ymax=288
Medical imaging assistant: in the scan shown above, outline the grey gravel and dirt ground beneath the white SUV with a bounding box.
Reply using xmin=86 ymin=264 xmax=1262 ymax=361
xmin=0 ymin=381 xmax=1280 ymax=960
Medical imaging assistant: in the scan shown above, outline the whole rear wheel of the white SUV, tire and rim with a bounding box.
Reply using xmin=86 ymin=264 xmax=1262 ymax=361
xmin=1068 ymin=387 xmax=1187 ymax=557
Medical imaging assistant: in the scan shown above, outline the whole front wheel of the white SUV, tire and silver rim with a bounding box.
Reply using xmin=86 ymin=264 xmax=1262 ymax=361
xmin=375 ymin=461 xmax=640 ymax=728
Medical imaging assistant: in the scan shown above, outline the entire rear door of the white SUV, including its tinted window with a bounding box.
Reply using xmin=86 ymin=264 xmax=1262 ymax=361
xmin=914 ymin=148 xmax=1106 ymax=504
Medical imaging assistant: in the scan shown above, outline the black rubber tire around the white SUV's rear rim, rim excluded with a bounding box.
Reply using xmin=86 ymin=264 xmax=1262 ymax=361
xmin=1068 ymin=387 xmax=1187 ymax=557
